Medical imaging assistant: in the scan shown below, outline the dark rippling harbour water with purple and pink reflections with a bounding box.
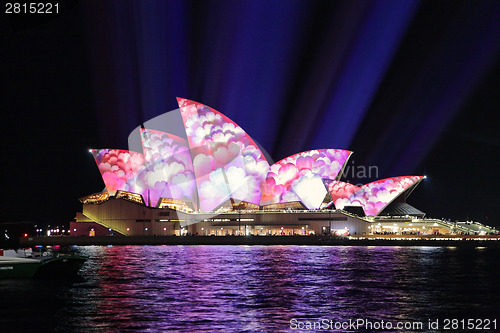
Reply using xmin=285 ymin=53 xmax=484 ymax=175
xmin=0 ymin=246 xmax=500 ymax=332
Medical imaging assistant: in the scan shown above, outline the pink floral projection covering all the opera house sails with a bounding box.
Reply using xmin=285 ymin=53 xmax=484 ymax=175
xmin=92 ymin=98 xmax=423 ymax=216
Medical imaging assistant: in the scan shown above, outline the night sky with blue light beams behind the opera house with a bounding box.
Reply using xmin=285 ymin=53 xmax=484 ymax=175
xmin=0 ymin=0 xmax=500 ymax=226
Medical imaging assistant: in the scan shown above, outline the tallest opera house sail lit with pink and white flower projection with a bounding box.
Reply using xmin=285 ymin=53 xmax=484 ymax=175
xmin=178 ymin=98 xmax=269 ymax=211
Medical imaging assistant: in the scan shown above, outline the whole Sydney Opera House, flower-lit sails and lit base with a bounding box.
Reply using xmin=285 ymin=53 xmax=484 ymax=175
xmin=71 ymin=98 xmax=460 ymax=236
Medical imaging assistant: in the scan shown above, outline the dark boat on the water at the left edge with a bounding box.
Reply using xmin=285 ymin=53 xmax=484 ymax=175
xmin=0 ymin=249 xmax=87 ymax=279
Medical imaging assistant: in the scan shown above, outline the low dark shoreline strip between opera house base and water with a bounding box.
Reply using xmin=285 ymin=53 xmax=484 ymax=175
xmin=19 ymin=235 xmax=500 ymax=248
